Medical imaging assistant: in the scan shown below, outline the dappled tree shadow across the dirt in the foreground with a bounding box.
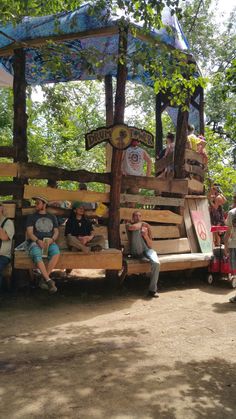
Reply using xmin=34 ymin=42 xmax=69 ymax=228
xmin=0 ymin=325 xmax=236 ymax=419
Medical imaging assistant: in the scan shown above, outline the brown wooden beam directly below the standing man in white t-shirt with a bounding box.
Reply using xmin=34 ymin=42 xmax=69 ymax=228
xmin=122 ymin=176 xmax=188 ymax=195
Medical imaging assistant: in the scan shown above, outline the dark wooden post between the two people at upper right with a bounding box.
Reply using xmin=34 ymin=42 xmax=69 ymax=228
xmin=174 ymin=107 xmax=188 ymax=179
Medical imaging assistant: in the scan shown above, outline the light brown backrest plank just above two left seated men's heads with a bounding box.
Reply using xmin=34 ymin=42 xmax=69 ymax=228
xmin=24 ymin=185 xmax=110 ymax=202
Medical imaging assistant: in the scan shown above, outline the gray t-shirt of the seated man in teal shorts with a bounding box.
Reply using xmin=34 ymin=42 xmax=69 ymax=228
xmin=26 ymin=213 xmax=58 ymax=240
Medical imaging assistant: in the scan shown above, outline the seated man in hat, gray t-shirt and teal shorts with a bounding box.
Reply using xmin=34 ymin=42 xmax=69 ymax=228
xmin=26 ymin=196 xmax=60 ymax=294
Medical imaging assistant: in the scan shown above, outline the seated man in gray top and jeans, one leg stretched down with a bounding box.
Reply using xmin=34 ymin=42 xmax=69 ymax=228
xmin=127 ymin=211 xmax=160 ymax=298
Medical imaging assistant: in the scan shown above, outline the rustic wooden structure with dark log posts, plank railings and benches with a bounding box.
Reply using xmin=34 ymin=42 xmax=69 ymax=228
xmin=0 ymin=5 xmax=211 ymax=282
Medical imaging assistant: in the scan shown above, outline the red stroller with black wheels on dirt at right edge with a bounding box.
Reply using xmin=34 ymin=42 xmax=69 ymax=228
xmin=207 ymin=226 xmax=236 ymax=288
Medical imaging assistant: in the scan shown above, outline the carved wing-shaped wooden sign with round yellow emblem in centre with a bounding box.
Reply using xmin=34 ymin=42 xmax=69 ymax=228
xmin=85 ymin=124 xmax=154 ymax=150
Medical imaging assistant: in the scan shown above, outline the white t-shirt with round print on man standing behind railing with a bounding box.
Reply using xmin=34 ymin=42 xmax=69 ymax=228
xmin=122 ymin=146 xmax=147 ymax=176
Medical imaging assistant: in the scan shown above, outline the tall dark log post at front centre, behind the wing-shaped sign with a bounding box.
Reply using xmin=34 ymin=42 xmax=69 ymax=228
xmin=108 ymin=27 xmax=128 ymax=249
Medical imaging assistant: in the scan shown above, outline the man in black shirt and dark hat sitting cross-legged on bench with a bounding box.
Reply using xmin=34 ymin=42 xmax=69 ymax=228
xmin=65 ymin=202 xmax=104 ymax=253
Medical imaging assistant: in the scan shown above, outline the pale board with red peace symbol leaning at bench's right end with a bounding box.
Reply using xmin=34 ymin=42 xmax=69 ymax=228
xmin=190 ymin=211 xmax=212 ymax=253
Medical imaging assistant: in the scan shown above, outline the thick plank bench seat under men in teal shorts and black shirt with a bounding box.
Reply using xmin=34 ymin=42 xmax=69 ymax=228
xmin=14 ymin=249 xmax=122 ymax=270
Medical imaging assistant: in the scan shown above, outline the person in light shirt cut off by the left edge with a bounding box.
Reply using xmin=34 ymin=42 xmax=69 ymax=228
xmin=0 ymin=202 xmax=15 ymax=290
